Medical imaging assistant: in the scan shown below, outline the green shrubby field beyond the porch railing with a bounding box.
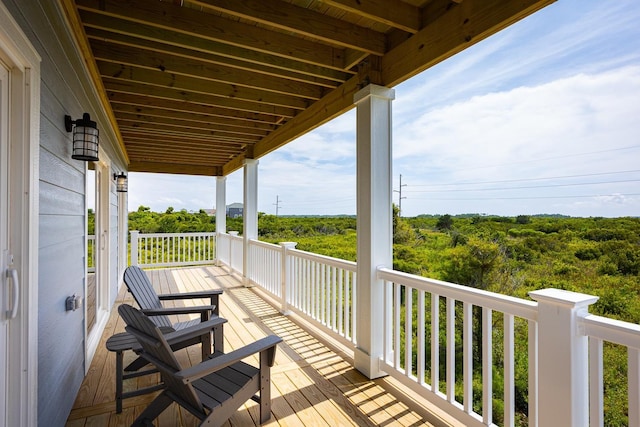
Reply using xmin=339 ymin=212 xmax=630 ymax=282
xmin=129 ymin=207 xmax=640 ymax=426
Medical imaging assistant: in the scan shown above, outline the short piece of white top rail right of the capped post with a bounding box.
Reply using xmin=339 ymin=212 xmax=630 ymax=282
xmin=579 ymin=314 xmax=640 ymax=350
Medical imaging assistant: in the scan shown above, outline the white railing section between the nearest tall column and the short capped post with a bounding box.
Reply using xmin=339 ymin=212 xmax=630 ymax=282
xmin=378 ymin=268 xmax=538 ymax=426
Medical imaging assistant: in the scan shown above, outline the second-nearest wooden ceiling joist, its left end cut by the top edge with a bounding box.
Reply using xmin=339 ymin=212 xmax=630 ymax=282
xmin=191 ymin=0 xmax=386 ymax=55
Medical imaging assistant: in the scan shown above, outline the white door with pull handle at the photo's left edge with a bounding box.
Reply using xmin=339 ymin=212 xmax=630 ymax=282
xmin=0 ymin=57 xmax=11 ymax=426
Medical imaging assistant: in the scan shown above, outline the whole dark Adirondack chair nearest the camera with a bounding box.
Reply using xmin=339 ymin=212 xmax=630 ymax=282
xmin=118 ymin=304 xmax=282 ymax=426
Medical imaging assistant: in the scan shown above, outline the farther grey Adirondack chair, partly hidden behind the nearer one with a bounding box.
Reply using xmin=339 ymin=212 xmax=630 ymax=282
xmin=124 ymin=266 xmax=224 ymax=362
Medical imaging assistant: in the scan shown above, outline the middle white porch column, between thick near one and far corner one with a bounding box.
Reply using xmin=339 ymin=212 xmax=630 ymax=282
xmin=242 ymin=159 xmax=259 ymax=286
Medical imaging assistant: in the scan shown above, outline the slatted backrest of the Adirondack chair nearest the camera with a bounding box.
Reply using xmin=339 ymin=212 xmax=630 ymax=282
xmin=118 ymin=304 xmax=204 ymax=412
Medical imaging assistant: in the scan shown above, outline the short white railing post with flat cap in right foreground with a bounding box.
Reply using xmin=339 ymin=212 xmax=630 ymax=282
xmin=529 ymin=289 xmax=598 ymax=427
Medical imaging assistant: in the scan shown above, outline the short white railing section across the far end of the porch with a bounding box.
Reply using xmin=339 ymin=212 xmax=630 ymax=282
xmin=131 ymin=230 xmax=216 ymax=267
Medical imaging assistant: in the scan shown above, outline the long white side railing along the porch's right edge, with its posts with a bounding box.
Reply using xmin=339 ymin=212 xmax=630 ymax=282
xmin=140 ymin=233 xmax=640 ymax=427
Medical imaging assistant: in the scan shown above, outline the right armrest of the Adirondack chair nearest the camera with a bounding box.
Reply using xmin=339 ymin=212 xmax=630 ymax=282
xmin=175 ymin=335 xmax=282 ymax=384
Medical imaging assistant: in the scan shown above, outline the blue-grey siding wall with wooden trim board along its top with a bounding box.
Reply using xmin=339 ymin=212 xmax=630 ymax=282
xmin=2 ymin=0 xmax=125 ymax=426
